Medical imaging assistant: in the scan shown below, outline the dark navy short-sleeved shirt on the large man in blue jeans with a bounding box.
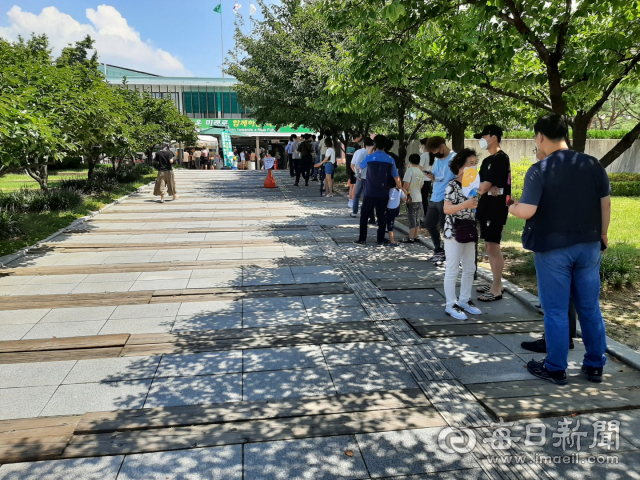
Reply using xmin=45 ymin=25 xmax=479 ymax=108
xmin=520 ymin=149 xmax=611 ymax=252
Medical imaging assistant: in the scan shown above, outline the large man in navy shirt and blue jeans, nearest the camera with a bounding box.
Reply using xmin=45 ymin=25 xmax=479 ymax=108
xmin=509 ymin=114 xmax=611 ymax=385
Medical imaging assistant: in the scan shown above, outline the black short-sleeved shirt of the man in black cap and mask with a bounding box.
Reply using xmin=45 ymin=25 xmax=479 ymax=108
xmin=477 ymin=150 xmax=511 ymax=225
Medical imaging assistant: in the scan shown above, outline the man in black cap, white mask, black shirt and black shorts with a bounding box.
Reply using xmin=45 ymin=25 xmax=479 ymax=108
xmin=474 ymin=125 xmax=511 ymax=302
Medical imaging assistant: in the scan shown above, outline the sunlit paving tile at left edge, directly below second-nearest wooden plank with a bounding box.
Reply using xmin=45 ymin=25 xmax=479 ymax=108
xmin=0 ymin=360 xmax=76 ymax=388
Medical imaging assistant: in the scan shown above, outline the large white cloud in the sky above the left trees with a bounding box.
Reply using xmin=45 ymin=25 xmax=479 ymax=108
xmin=0 ymin=5 xmax=192 ymax=76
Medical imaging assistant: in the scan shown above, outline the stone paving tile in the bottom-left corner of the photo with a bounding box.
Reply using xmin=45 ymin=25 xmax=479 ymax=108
xmin=0 ymin=455 xmax=124 ymax=480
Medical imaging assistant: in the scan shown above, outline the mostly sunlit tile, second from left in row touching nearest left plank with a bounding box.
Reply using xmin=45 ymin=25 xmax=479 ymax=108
xmin=40 ymin=379 xmax=151 ymax=417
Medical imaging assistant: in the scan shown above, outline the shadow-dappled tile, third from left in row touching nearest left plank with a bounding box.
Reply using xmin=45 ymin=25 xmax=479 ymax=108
xmin=144 ymin=373 xmax=242 ymax=408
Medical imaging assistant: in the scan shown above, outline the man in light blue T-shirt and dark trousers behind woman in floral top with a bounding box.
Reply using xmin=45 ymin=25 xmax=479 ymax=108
xmin=425 ymin=136 xmax=456 ymax=263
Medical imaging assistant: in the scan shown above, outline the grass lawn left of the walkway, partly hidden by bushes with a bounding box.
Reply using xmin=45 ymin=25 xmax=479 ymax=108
xmin=0 ymin=171 xmax=156 ymax=257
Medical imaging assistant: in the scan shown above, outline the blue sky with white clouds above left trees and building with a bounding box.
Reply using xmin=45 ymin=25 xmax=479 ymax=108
xmin=0 ymin=0 xmax=272 ymax=77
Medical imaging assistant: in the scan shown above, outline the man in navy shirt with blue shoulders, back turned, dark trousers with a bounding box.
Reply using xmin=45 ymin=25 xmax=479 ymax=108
xmin=353 ymin=135 xmax=402 ymax=245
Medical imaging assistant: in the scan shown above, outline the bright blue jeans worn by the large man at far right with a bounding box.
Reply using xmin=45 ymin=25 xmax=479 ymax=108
xmin=535 ymin=242 xmax=607 ymax=371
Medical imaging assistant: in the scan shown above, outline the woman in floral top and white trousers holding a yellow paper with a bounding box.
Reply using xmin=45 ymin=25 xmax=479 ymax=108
xmin=443 ymin=148 xmax=482 ymax=320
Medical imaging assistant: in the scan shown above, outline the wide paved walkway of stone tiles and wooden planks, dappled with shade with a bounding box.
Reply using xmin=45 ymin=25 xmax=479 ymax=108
xmin=0 ymin=170 xmax=640 ymax=480
